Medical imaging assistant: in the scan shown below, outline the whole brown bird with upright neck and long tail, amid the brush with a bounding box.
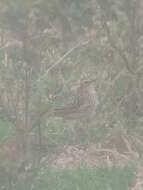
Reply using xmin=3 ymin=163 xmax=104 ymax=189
xmin=30 ymin=80 xmax=99 ymax=130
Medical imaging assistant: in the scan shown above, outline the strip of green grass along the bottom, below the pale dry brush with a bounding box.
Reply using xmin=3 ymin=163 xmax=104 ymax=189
xmin=33 ymin=163 xmax=135 ymax=190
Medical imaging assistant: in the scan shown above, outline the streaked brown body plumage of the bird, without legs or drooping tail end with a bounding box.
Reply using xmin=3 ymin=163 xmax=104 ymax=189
xmin=54 ymin=81 xmax=98 ymax=120
